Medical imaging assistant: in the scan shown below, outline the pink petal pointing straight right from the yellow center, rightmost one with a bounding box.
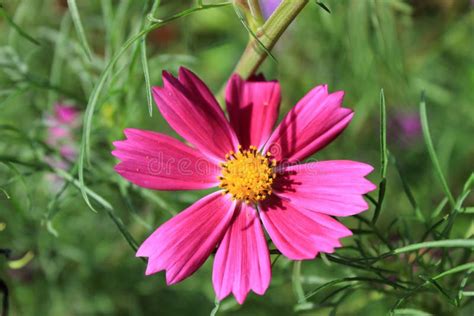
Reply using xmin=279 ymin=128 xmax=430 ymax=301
xmin=273 ymin=160 xmax=376 ymax=216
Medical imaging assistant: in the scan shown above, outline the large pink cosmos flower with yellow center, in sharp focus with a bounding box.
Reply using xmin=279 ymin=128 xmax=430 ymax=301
xmin=112 ymin=68 xmax=375 ymax=303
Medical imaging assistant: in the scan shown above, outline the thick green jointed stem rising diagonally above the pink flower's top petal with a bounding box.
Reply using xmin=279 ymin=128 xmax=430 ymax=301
xmin=234 ymin=0 xmax=308 ymax=78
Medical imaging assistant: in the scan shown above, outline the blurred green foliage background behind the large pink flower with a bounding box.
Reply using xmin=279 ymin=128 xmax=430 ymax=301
xmin=0 ymin=0 xmax=474 ymax=315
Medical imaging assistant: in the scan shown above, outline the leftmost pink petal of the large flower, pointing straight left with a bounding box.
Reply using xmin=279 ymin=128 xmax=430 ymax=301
xmin=112 ymin=128 xmax=220 ymax=190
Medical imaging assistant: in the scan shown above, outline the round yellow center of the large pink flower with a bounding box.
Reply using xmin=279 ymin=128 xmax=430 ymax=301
xmin=219 ymin=146 xmax=276 ymax=204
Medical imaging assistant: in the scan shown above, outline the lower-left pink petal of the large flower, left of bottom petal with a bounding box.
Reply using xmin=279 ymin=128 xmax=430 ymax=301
xmin=137 ymin=192 xmax=235 ymax=285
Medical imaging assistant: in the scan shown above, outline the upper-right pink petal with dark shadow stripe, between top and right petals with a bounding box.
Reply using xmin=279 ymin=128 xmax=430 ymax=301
xmin=264 ymin=85 xmax=353 ymax=162
